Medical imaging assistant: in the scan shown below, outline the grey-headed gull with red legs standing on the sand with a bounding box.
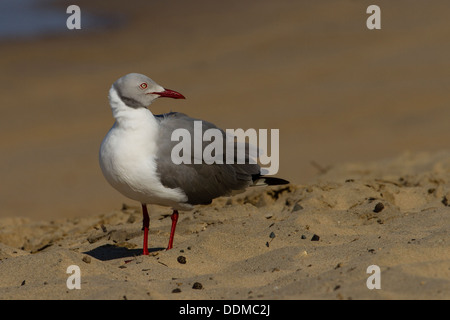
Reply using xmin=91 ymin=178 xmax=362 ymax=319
xmin=99 ymin=73 xmax=289 ymax=255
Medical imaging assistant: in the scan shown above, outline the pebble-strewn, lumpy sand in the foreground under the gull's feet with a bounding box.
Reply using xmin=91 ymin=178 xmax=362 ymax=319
xmin=0 ymin=152 xmax=450 ymax=299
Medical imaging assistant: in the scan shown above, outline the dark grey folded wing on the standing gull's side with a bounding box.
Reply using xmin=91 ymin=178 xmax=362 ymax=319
xmin=155 ymin=112 xmax=260 ymax=204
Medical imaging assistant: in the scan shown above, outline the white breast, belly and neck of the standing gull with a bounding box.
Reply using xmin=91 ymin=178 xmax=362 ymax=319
xmin=99 ymin=88 xmax=187 ymax=209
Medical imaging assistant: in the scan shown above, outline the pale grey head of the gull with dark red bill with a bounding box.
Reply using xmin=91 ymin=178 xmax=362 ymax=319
xmin=111 ymin=73 xmax=186 ymax=108
